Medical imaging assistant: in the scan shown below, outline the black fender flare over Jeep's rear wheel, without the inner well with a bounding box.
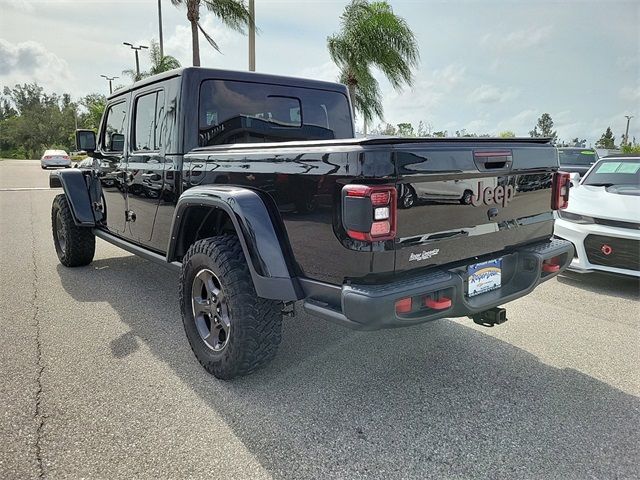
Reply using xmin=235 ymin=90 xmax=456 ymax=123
xmin=167 ymin=185 xmax=304 ymax=301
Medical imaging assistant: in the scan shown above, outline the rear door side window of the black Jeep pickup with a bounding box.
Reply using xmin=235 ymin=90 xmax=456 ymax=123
xmin=133 ymin=91 xmax=164 ymax=151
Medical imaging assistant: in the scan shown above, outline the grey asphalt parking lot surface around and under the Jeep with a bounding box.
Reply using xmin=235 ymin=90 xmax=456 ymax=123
xmin=0 ymin=160 xmax=640 ymax=479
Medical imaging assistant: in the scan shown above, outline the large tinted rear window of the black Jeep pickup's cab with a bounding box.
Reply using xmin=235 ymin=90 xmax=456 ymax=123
xmin=198 ymin=80 xmax=353 ymax=147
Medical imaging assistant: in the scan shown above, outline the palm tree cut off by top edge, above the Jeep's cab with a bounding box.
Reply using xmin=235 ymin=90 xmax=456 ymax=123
xmin=171 ymin=0 xmax=253 ymax=67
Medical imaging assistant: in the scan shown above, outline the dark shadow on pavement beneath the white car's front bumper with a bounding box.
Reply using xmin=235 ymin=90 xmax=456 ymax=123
xmin=556 ymin=271 xmax=640 ymax=300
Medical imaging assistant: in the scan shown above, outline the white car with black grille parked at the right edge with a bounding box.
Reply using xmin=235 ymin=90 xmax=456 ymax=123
xmin=554 ymin=155 xmax=640 ymax=277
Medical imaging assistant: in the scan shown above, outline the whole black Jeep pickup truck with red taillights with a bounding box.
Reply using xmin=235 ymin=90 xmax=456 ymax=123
xmin=50 ymin=68 xmax=573 ymax=379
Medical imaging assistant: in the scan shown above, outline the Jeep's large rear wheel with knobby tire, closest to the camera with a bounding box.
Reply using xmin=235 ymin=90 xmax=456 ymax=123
xmin=179 ymin=235 xmax=282 ymax=380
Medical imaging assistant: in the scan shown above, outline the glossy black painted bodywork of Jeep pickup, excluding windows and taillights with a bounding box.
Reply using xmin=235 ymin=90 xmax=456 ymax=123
xmin=56 ymin=68 xmax=576 ymax=326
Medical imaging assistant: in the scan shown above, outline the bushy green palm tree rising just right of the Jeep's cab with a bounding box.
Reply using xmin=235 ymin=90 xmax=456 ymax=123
xmin=327 ymin=0 xmax=420 ymax=125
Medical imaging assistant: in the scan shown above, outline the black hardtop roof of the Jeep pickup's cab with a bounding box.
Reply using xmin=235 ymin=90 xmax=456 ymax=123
xmin=109 ymin=67 xmax=347 ymax=99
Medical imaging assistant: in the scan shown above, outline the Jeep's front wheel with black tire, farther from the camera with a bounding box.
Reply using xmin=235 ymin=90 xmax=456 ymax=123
xmin=51 ymin=194 xmax=96 ymax=267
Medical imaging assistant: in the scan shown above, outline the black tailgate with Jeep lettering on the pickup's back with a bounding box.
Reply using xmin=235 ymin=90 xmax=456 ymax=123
xmin=395 ymin=140 xmax=558 ymax=273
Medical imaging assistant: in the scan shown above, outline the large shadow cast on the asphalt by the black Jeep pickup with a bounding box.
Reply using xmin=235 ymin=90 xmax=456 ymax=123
xmin=58 ymin=256 xmax=640 ymax=479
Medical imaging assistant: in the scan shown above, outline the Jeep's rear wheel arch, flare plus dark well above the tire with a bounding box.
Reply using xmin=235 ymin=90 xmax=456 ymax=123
xmin=167 ymin=185 xmax=303 ymax=301
